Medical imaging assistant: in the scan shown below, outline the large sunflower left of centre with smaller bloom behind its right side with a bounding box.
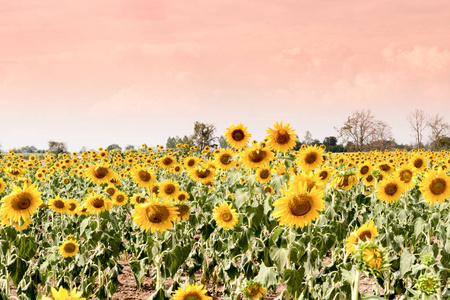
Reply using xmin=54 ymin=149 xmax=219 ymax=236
xmin=133 ymin=199 xmax=178 ymax=233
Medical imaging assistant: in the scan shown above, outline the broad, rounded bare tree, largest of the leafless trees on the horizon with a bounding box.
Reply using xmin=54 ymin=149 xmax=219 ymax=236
xmin=335 ymin=110 xmax=376 ymax=151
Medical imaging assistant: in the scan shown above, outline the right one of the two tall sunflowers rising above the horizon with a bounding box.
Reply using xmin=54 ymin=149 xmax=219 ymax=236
xmin=266 ymin=122 xmax=297 ymax=152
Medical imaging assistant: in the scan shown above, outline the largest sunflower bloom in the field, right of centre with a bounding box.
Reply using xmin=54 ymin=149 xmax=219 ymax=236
xmin=272 ymin=184 xmax=325 ymax=228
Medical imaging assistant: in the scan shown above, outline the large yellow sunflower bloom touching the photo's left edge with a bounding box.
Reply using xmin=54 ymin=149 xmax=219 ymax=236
xmin=0 ymin=184 xmax=42 ymax=222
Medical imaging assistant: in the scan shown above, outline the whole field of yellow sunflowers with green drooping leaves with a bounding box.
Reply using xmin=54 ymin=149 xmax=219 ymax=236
xmin=0 ymin=122 xmax=450 ymax=300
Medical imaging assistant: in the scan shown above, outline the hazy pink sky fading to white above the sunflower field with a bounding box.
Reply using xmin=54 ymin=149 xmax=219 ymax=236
xmin=0 ymin=0 xmax=450 ymax=151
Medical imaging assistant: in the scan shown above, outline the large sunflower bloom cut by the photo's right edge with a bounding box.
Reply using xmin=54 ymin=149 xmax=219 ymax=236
xmin=419 ymin=170 xmax=450 ymax=205
